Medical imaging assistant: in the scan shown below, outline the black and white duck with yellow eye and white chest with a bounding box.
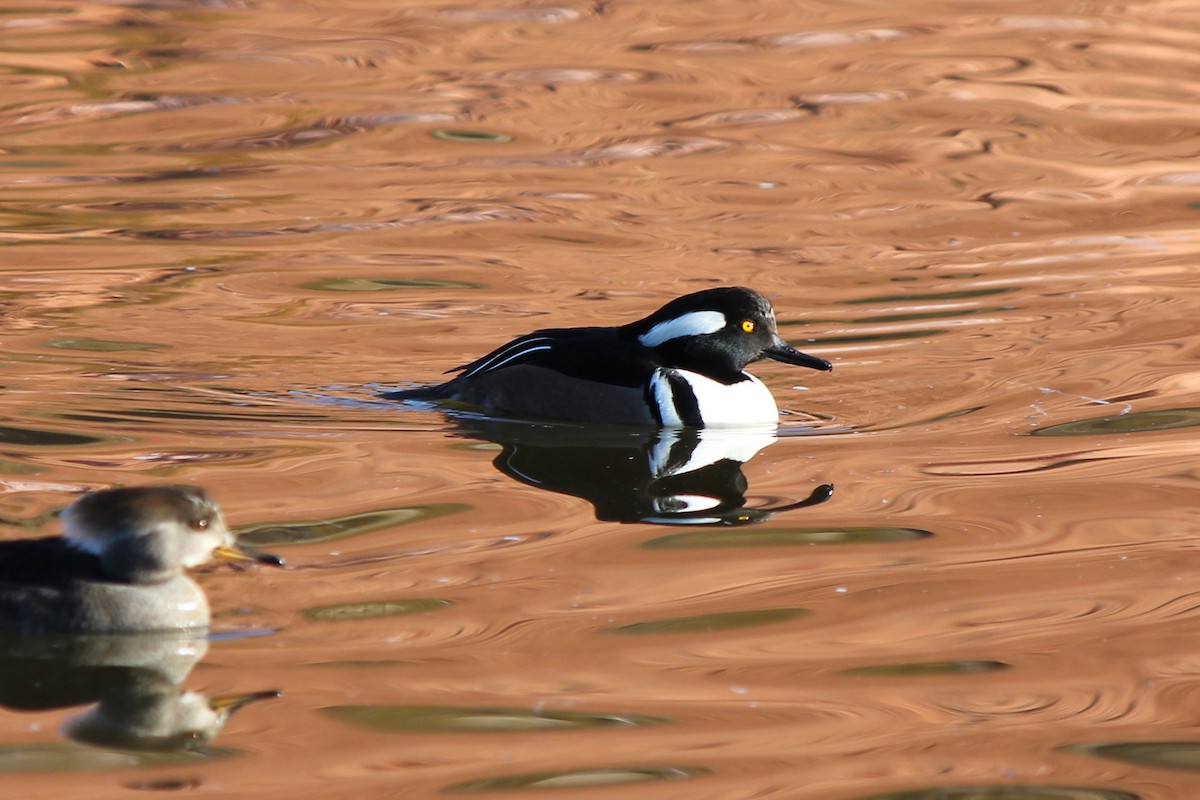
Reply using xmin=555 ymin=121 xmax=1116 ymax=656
xmin=383 ymin=287 xmax=833 ymax=427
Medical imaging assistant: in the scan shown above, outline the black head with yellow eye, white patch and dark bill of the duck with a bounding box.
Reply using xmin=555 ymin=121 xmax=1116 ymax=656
xmin=624 ymin=287 xmax=833 ymax=384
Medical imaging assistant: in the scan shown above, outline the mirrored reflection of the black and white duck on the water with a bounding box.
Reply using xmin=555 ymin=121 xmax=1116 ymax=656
xmin=458 ymin=419 xmax=833 ymax=525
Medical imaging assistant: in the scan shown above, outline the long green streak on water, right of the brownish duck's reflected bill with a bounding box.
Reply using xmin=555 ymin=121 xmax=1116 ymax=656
xmin=322 ymin=705 xmax=668 ymax=733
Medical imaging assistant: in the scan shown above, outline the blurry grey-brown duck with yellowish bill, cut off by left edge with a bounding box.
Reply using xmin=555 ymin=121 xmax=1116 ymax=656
xmin=0 ymin=486 xmax=283 ymax=633
